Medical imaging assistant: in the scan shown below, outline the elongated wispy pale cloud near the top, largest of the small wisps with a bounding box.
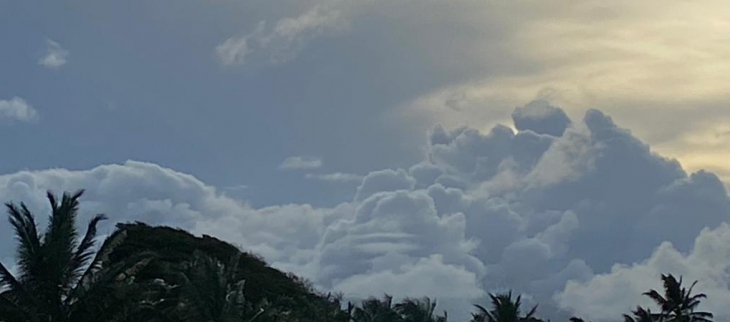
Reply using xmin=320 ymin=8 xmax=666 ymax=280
xmin=215 ymin=6 xmax=347 ymax=65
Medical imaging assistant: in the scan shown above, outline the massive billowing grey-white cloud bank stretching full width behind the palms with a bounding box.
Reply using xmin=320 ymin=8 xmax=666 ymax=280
xmin=0 ymin=102 xmax=730 ymax=321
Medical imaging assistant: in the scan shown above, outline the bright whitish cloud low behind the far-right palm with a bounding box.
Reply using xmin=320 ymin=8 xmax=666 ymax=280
xmin=555 ymin=223 xmax=730 ymax=321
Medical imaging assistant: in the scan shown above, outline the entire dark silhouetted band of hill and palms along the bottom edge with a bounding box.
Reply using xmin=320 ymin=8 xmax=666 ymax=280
xmin=0 ymin=192 xmax=712 ymax=322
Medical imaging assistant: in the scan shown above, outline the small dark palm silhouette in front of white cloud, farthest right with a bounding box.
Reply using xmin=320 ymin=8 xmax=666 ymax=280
xmin=644 ymin=274 xmax=713 ymax=322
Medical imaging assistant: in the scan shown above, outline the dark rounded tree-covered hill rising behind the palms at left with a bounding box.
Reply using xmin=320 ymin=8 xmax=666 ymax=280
xmin=109 ymin=223 xmax=340 ymax=320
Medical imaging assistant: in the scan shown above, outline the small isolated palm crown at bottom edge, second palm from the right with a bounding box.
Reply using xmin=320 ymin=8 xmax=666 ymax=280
xmin=472 ymin=291 xmax=537 ymax=322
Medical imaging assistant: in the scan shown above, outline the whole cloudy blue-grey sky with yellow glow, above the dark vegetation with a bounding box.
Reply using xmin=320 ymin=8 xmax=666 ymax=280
xmin=0 ymin=0 xmax=730 ymax=322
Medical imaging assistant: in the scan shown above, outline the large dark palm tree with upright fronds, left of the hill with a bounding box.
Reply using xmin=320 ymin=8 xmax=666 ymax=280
xmin=0 ymin=191 xmax=152 ymax=322
